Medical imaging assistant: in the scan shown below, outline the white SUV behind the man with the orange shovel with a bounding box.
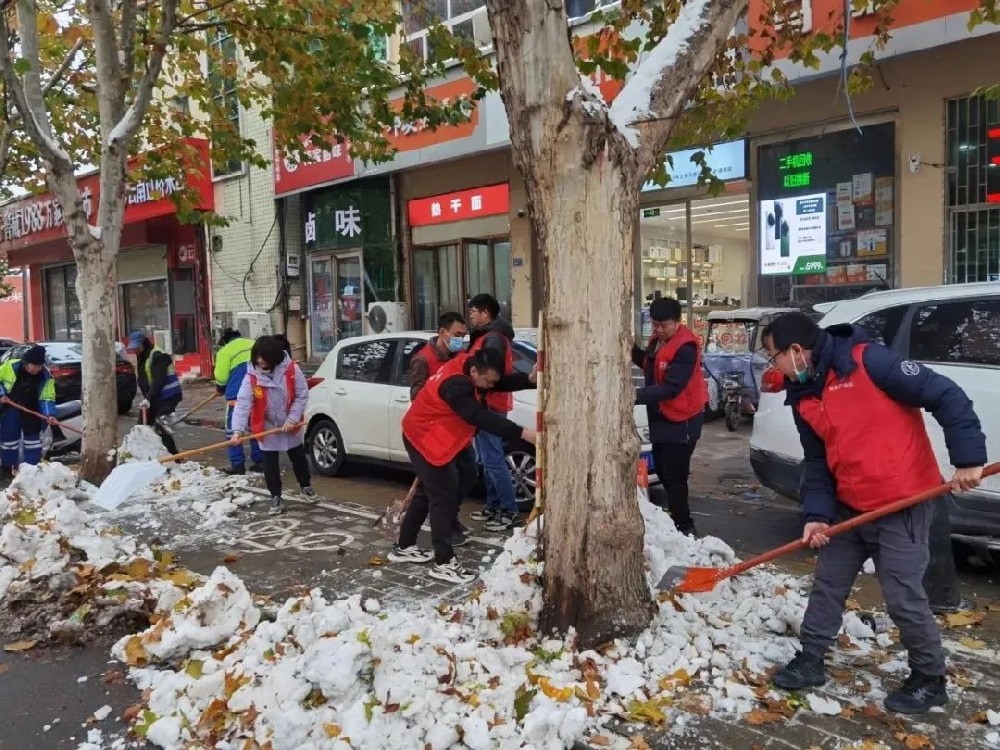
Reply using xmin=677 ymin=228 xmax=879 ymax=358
xmin=750 ymin=282 xmax=1000 ymax=557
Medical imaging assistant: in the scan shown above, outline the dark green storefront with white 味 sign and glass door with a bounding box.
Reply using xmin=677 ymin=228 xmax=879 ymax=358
xmin=302 ymin=178 xmax=399 ymax=359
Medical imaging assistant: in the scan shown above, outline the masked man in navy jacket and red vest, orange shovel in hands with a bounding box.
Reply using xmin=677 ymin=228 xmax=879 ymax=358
xmin=761 ymin=313 xmax=986 ymax=714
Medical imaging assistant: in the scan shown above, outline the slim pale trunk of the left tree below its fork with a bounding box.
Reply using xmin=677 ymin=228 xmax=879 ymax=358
xmin=74 ymin=239 xmax=118 ymax=484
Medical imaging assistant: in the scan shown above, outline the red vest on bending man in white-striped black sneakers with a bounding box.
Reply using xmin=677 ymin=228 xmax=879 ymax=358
xmin=403 ymin=354 xmax=476 ymax=466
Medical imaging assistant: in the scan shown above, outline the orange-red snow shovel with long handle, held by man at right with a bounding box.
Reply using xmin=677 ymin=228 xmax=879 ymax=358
xmin=656 ymin=463 xmax=1000 ymax=594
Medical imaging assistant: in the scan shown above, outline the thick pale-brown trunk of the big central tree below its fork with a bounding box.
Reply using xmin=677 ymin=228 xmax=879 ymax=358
xmin=525 ymin=141 xmax=652 ymax=646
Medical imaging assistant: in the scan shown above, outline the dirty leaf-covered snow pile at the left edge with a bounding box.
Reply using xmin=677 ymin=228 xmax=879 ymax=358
xmin=0 ymin=464 xmax=209 ymax=641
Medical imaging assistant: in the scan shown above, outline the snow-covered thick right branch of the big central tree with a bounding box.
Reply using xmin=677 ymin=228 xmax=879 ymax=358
xmin=610 ymin=0 xmax=747 ymax=174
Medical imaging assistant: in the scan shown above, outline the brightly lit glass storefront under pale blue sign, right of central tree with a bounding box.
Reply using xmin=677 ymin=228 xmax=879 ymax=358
xmin=635 ymin=140 xmax=753 ymax=339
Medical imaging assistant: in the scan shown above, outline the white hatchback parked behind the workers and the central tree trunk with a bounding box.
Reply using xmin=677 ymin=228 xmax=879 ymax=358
xmin=306 ymin=331 xmax=653 ymax=510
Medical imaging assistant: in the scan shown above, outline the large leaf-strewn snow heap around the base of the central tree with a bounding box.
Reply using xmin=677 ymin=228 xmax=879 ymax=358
xmin=114 ymin=494 xmax=884 ymax=750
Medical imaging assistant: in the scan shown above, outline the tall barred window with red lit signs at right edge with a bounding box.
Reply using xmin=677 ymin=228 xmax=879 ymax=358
xmin=946 ymin=96 xmax=1000 ymax=284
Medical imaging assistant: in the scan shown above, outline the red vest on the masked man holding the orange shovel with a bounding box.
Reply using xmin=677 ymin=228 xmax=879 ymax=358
xmin=795 ymin=344 xmax=941 ymax=512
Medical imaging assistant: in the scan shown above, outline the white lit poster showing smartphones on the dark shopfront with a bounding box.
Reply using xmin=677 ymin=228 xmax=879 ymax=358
xmin=758 ymin=193 xmax=827 ymax=276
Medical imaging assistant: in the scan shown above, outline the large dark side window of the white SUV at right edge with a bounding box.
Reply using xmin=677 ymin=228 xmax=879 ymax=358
xmin=910 ymin=297 xmax=1000 ymax=367
